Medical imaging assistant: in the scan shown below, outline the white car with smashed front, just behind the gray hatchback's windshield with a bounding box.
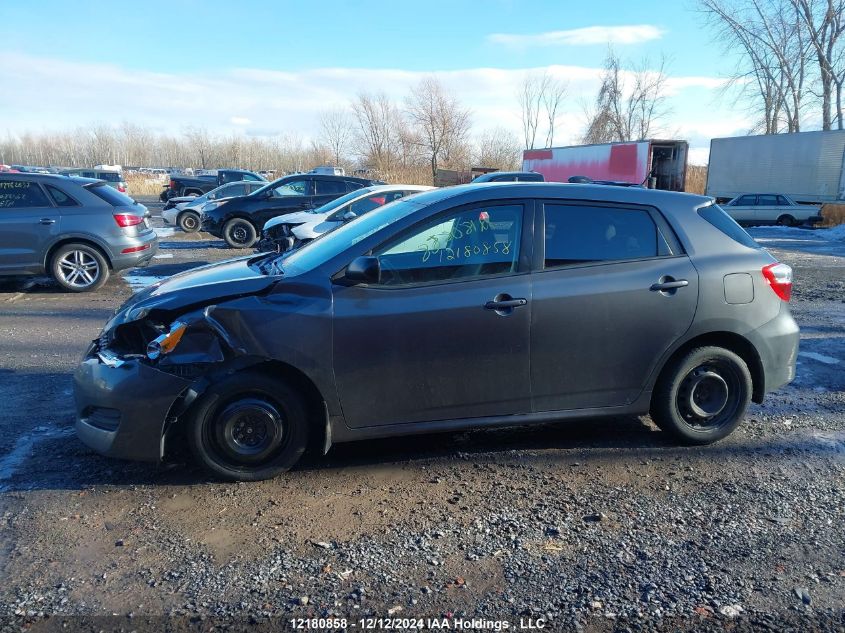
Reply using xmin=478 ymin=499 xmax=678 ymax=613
xmin=258 ymin=185 xmax=434 ymax=252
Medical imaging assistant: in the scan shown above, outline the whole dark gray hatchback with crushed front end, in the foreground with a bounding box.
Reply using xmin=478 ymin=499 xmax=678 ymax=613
xmin=75 ymin=183 xmax=798 ymax=480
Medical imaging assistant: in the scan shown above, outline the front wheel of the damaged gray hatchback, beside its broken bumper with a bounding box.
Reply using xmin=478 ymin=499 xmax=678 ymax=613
xmin=187 ymin=371 xmax=308 ymax=481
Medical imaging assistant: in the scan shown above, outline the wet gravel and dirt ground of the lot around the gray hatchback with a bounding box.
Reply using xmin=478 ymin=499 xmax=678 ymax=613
xmin=0 ymin=204 xmax=845 ymax=631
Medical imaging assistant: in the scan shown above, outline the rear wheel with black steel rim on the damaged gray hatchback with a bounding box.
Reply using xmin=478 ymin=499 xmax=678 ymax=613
xmin=651 ymin=347 xmax=752 ymax=444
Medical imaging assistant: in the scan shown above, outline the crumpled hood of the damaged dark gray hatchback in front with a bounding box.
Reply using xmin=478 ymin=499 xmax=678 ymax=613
xmin=106 ymin=255 xmax=279 ymax=330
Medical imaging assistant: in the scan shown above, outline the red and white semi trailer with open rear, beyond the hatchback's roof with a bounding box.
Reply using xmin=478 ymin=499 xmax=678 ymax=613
xmin=522 ymin=140 xmax=689 ymax=191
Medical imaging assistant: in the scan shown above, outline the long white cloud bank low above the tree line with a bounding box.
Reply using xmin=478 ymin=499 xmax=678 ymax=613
xmin=0 ymin=54 xmax=747 ymax=163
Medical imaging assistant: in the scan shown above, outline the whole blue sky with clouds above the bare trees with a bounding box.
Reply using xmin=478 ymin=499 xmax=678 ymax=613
xmin=0 ymin=0 xmax=750 ymax=163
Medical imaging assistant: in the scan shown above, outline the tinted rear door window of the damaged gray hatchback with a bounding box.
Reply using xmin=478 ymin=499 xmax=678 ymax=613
xmin=545 ymin=204 xmax=670 ymax=268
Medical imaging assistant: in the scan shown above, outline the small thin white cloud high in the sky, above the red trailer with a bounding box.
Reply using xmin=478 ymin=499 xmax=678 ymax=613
xmin=487 ymin=24 xmax=663 ymax=48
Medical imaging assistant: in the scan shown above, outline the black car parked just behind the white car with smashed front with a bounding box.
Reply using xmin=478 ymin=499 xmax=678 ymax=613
xmin=202 ymin=174 xmax=384 ymax=248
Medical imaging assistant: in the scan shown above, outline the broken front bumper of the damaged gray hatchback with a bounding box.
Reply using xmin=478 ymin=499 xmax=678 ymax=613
xmin=73 ymin=343 xmax=192 ymax=462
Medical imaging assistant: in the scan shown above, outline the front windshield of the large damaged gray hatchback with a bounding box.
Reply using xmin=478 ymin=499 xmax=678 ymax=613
xmin=276 ymin=199 xmax=421 ymax=276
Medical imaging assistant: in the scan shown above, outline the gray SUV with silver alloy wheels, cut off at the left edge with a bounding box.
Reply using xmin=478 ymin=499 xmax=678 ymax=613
xmin=0 ymin=173 xmax=158 ymax=292
